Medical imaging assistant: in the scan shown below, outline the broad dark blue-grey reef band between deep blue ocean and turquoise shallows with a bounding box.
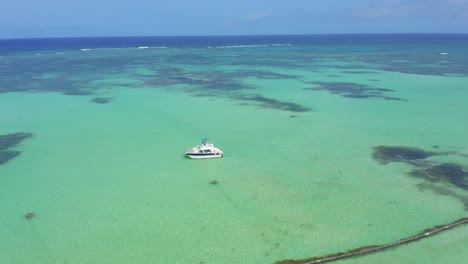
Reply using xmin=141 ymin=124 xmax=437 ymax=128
xmin=0 ymin=45 xmax=468 ymax=98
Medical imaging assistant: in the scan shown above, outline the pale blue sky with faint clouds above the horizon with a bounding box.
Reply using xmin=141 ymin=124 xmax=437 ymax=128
xmin=0 ymin=0 xmax=468 ymax=38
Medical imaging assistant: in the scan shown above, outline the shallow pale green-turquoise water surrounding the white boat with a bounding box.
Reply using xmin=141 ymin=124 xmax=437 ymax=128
xmin=0 ymin=36 xmax=468 ymax=264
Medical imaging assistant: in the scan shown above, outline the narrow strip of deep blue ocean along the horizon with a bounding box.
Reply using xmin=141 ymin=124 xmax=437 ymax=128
xmin=0 ymin=34 xmax=468 ymax=55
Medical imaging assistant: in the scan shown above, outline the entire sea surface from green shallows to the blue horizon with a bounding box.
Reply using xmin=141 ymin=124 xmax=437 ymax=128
xmin=0 ymin=36 xmax=468 ymax=263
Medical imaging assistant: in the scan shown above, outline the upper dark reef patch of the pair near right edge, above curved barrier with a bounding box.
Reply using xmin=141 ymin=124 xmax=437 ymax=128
xmin=372 ymin=146 xmax=442 ymax=165
